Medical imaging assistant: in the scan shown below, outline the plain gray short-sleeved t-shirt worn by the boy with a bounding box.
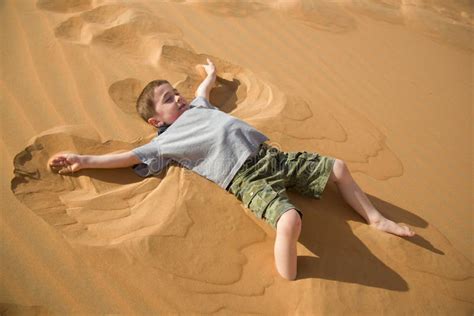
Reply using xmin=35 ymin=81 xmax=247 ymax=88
xmin=132 ymin=96 xmax=268 ymax=189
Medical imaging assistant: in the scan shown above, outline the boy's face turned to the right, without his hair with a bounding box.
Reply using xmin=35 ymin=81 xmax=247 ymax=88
xmin=148 ymin=83 xmax=189 ymax=127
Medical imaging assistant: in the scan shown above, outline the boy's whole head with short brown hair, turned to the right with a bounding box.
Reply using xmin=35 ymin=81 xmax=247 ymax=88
xmin=137 ymin=80 xmax=189 ymax=127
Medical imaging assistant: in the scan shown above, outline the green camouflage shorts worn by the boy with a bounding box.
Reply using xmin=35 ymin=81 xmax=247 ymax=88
xmin=227 ymin=143 xmax=336 ymax=229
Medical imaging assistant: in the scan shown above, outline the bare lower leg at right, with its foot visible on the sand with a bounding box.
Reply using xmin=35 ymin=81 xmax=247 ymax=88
xmin=329 ymin=159 xmax=415 ymax=237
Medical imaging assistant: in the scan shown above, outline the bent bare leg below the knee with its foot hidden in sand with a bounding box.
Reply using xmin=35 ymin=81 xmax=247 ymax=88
xmin=274 ymin=209 xmax=301 ymax=280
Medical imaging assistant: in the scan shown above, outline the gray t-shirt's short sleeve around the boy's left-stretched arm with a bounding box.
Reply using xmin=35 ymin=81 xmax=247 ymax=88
xmin=132 ymin=140 xmax=170 ymax=177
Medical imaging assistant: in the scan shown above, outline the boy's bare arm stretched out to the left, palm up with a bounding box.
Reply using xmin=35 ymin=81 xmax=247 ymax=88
xmin=48 ymin=151 xmax=141 ymax=174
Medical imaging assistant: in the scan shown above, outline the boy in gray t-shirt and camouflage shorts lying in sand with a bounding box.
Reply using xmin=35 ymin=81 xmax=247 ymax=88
xmin=49 ymin=59 xmax=415 ymax=280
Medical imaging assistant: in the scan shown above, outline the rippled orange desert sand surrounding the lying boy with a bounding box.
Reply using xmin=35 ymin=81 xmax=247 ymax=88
xmin=0 ymin=0 xmax=474 ymax=315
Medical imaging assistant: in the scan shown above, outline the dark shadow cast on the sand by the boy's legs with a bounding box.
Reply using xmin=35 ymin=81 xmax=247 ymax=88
xmin=288 ymin=183 xmax=444 ymax=291
